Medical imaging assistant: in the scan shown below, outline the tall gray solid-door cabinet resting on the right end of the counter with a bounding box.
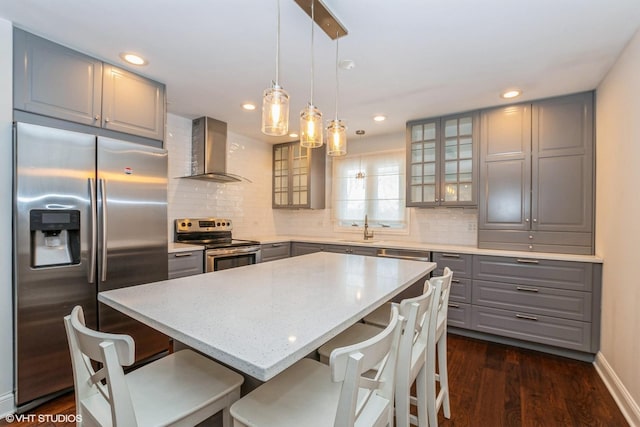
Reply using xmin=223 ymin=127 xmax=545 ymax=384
xmin=478 ymin=92 xmax=594 ymax=254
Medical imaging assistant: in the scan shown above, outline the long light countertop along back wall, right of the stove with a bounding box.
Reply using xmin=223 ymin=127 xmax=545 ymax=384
xmin=246 ymin=235 xmax=603 ymax=263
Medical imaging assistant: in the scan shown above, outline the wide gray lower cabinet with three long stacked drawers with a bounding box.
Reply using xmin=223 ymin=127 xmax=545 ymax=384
xmin=471 ymin=255 xmax=602 ymax=354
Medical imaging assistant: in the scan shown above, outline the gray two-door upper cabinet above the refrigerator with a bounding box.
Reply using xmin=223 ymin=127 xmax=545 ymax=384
xmin=13 ymin=29 xmax=165 ymax=140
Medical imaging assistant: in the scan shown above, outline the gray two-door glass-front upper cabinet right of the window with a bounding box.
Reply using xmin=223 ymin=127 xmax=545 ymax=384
xmin=406 ymin=113 xmax=478 ymax=207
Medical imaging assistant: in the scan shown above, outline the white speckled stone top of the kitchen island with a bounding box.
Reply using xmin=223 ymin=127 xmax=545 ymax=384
xmin=98 ymin=252 xmax=436 ymax=381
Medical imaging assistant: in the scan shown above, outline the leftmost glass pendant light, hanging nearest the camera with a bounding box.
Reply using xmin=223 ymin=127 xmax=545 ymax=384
xmin=262 ymin=0 xmax=289 ymax=136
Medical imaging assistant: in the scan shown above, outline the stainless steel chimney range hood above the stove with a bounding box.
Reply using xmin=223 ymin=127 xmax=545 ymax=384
xmin=183 ymin=117 xmax=251 ymax=182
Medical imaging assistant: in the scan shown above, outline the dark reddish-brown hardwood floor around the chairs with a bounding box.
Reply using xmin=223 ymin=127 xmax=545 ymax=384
xmin=0 ymin=335 xmax=628 ymax=427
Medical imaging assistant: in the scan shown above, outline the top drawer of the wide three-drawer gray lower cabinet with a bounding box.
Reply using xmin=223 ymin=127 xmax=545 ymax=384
xmin=473 ymin=255 xmax=593 ymax=291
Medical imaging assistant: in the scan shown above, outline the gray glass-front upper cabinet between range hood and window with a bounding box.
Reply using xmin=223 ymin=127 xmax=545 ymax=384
xmin=272 ymin=141 xmax=326 ymax=209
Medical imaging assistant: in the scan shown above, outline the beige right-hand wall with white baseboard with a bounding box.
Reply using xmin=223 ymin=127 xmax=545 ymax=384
xmin=596 ymin=28 xmax=640 ymax=425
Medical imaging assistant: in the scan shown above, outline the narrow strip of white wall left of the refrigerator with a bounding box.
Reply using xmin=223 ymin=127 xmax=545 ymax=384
xmin=0 ymin=19 xmax=14 ymax=419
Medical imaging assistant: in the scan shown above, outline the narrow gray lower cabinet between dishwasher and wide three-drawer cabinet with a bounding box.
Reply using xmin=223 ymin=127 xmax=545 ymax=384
xmin=431 ymin=252 xmax=473 ymax=329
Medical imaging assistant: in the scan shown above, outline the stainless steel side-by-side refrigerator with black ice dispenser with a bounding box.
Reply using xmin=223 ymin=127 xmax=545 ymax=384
xmin=13 ymin=123 xmax=169 ymax=411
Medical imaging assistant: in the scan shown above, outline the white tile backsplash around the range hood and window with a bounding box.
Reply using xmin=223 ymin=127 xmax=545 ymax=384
xmin=165 ymin=114 xmax=477 ymax=246
